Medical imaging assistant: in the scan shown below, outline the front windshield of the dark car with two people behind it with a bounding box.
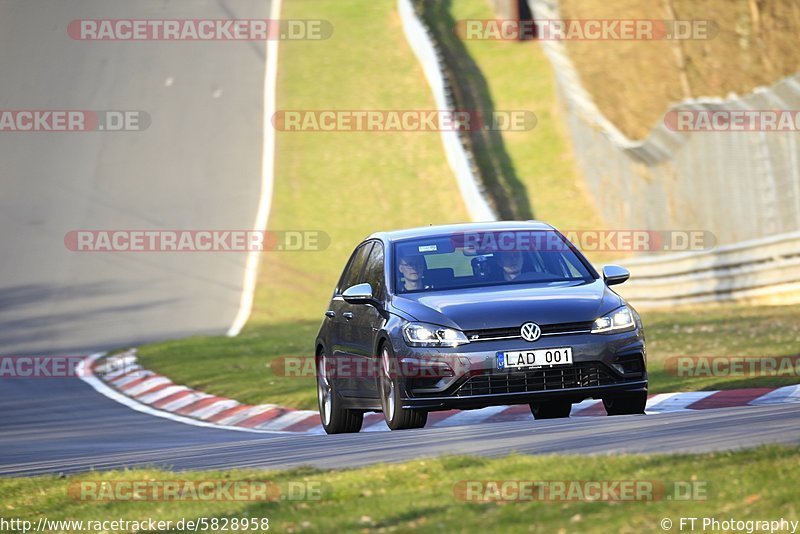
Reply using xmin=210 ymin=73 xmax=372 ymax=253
xmin=394 ymin=230 xmax=594 ymax=293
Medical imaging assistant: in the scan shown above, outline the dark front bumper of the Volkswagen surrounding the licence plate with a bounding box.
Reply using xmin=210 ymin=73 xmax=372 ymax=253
xmin=395 ymin=328 xmax=647 ymax=411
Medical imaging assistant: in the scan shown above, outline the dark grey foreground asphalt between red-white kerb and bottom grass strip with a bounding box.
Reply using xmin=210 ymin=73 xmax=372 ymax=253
xmin=0 ymin=378 xmax=800 ymax=476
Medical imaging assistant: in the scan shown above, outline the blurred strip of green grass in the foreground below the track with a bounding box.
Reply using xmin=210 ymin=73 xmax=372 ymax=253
xmin=0 ymin=446 xmax=800 ymax=532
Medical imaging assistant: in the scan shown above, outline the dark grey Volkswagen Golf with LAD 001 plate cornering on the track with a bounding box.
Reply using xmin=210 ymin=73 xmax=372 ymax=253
xmin=315 ymin=221 xmax=647 ymax=434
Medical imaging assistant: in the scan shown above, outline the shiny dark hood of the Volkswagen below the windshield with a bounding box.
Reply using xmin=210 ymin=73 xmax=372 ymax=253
xmin=392 ymin=280 xmax=624 ymax=330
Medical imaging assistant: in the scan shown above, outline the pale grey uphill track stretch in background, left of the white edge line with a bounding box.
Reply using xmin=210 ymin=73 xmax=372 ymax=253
xmin=0 ymin=0 xmax=270 ymax=355
